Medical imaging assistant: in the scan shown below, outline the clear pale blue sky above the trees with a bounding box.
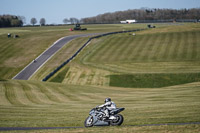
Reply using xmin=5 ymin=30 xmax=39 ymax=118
xmin=0 ymin=0 xmax=200 ymax=24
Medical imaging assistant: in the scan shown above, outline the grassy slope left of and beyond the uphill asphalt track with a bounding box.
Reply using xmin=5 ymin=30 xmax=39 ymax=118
xmin=0 ymin=25 xmax=146 ymax=79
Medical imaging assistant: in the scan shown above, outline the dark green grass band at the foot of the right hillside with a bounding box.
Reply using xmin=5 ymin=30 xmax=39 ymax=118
xmin=110 ymin=73 xmax=200 ymax=88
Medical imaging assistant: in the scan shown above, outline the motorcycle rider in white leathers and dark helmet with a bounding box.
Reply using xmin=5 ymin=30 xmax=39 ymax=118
xmin=99 ymin=98 xmax=116 ymax=118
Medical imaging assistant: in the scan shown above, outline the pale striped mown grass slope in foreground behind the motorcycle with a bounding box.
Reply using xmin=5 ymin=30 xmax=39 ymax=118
xmin=0 ymin=80 xmax=200 ymax=131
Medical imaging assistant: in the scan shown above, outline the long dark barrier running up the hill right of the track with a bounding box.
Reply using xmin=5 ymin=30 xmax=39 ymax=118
xmin=42 ymin=29 xmax=144 ymax=81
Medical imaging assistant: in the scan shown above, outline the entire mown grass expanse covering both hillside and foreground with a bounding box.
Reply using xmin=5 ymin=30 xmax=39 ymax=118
xmin=0 ymin=24 xmax=200 ymax=133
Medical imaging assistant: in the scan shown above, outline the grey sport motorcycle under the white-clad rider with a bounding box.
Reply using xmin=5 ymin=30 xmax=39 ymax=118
xmin=84 ymin=107 xmax=125 ymax=127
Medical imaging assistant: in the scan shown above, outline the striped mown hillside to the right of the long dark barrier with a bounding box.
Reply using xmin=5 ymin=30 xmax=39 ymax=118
xmin=39 ymin=24 xmax=200 ymax=88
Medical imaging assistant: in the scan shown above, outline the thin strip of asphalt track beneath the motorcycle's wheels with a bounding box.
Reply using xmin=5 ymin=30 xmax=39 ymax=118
xmin=0 ymin=122 xmax=200 ymax=131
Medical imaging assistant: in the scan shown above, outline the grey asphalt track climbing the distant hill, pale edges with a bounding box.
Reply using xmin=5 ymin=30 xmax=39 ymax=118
xmin=13 ymin=33 xmax=99 ymax=80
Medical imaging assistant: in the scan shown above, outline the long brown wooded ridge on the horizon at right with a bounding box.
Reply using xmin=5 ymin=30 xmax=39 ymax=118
xmin=80 ymin=8 xmax=200 ymax=23
